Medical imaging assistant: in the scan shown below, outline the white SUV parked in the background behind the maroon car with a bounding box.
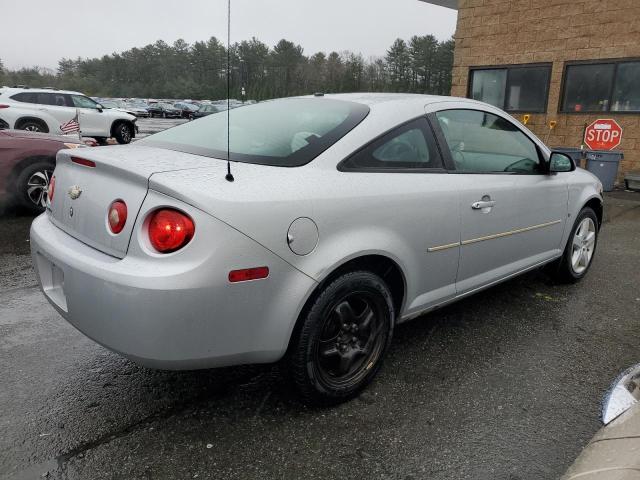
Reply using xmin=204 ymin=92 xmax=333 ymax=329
xmin=0 ymin=87 xmax=136 ymax=143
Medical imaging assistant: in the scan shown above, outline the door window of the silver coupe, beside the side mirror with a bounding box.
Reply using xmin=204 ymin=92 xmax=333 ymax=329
xmin=436 ymin=110 xmax=542 ymax=174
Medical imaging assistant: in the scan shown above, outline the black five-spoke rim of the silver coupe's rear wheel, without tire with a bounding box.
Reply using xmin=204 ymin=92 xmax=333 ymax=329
xmin=314 ymin=292 xmax=388 ymax=388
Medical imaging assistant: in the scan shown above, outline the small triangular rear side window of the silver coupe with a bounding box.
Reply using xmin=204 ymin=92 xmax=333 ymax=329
xmin=340 ymin=118 xmax=442 ymax=171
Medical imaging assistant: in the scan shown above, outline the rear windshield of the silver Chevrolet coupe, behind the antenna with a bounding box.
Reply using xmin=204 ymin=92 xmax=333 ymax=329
xmin=137 ymin=98 xmax=369 ymax=167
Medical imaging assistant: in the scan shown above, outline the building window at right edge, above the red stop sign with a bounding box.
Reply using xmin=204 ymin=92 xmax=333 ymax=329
xmin=562 ymin=60 xmax=640 ymax=113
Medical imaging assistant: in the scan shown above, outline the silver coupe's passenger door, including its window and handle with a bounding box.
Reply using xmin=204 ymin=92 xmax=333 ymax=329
xmin=433 ymin=107 xmax=568 ymax=295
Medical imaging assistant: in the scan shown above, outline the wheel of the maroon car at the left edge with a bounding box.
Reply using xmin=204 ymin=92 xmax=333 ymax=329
xmin=14 ymin=158 xmax=56 ymax=213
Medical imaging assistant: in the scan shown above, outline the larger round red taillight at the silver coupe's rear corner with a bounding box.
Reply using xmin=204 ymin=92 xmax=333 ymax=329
xmin=149 ymin=208 xmax=195 ymax=253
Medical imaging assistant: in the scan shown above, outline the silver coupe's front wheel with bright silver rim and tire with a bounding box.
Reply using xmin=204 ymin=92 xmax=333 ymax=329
xmin=546 ymin=207 xmax=599 ymax=283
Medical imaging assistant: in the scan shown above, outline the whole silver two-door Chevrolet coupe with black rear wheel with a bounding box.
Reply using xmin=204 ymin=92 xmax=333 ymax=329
xmin=31 ymin=94 xmax=603 ymax=404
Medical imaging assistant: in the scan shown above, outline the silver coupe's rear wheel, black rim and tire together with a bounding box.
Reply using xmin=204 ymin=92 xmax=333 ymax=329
xmin=286 ymin=271 xmax=395 ymax=406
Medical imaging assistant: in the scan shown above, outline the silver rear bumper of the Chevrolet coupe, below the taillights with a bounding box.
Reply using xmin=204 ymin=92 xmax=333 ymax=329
xmin=31 ymin=207 xmax=315 ymax=370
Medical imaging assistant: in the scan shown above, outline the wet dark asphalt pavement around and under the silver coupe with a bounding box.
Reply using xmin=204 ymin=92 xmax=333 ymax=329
xmin=0 ymin=189 xmax=640 ymax=480
